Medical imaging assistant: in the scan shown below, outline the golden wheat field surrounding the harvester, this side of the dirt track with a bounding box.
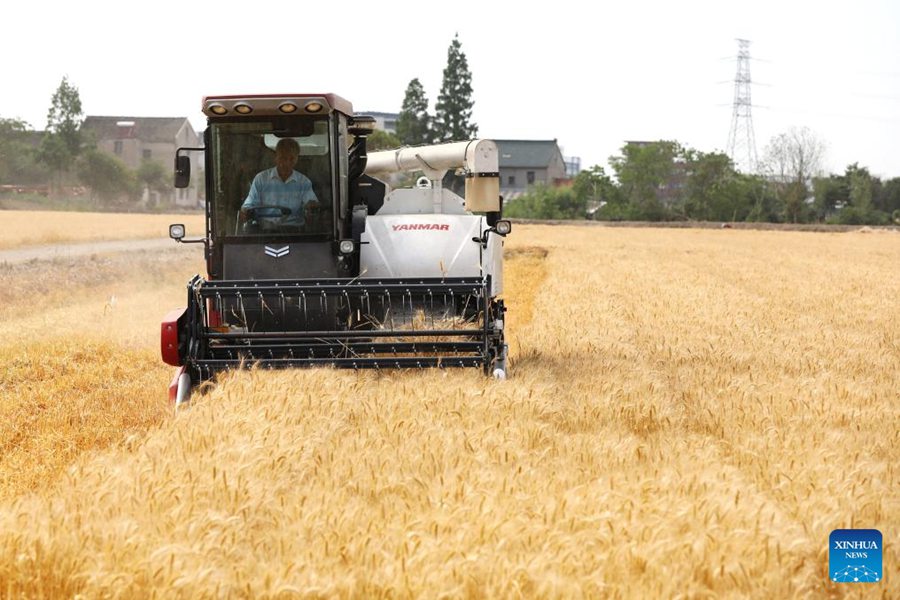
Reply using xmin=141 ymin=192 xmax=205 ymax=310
xmin=0 ymin=226 xmax=900 ymax=598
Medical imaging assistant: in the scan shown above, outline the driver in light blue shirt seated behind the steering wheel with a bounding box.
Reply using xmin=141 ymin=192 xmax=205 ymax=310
xmin=240 ymin=138 xmax=319 ymax=229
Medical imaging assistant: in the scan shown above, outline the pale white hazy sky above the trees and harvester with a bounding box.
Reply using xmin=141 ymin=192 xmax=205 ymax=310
xmin=0 ymin=0 xmax=900 ymax=177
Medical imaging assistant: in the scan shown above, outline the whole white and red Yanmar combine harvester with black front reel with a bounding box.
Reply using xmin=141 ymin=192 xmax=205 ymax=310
xmin=162 ymin=94 xmax=511 ymax=403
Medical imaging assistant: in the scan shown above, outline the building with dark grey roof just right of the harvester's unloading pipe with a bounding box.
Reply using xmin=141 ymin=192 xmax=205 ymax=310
xmin=494 ymin=140 xmax=569 ymax=200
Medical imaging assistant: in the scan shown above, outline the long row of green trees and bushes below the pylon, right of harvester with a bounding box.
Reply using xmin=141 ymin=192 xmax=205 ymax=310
xmin=504 ymin=128 xmax=900 ymax=225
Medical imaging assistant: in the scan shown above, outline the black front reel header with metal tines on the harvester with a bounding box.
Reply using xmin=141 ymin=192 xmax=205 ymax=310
xmin=185 ymin=275 xmax=506 ymax=383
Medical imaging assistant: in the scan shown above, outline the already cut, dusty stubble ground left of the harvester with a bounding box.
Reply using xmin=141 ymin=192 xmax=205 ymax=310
xmin=0 ymin=242 xmax=203 ymax=499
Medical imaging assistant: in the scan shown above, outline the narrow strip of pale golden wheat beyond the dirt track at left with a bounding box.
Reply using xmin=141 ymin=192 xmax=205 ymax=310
xmin=0 ymin=210 xmax=204 ymax=249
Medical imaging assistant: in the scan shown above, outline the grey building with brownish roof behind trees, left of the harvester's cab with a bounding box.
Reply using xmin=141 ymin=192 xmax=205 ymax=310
xmin=81 ymin=116 xmax=203 ymax=206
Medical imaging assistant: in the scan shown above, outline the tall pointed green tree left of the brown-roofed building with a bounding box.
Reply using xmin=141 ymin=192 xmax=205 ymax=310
xmin=38 ymin=77 xmax=83 ymax=188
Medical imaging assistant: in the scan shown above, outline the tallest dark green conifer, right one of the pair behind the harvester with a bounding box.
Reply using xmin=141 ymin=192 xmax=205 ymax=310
xmin=433 ymin=34 xmax=478 ymax=142
